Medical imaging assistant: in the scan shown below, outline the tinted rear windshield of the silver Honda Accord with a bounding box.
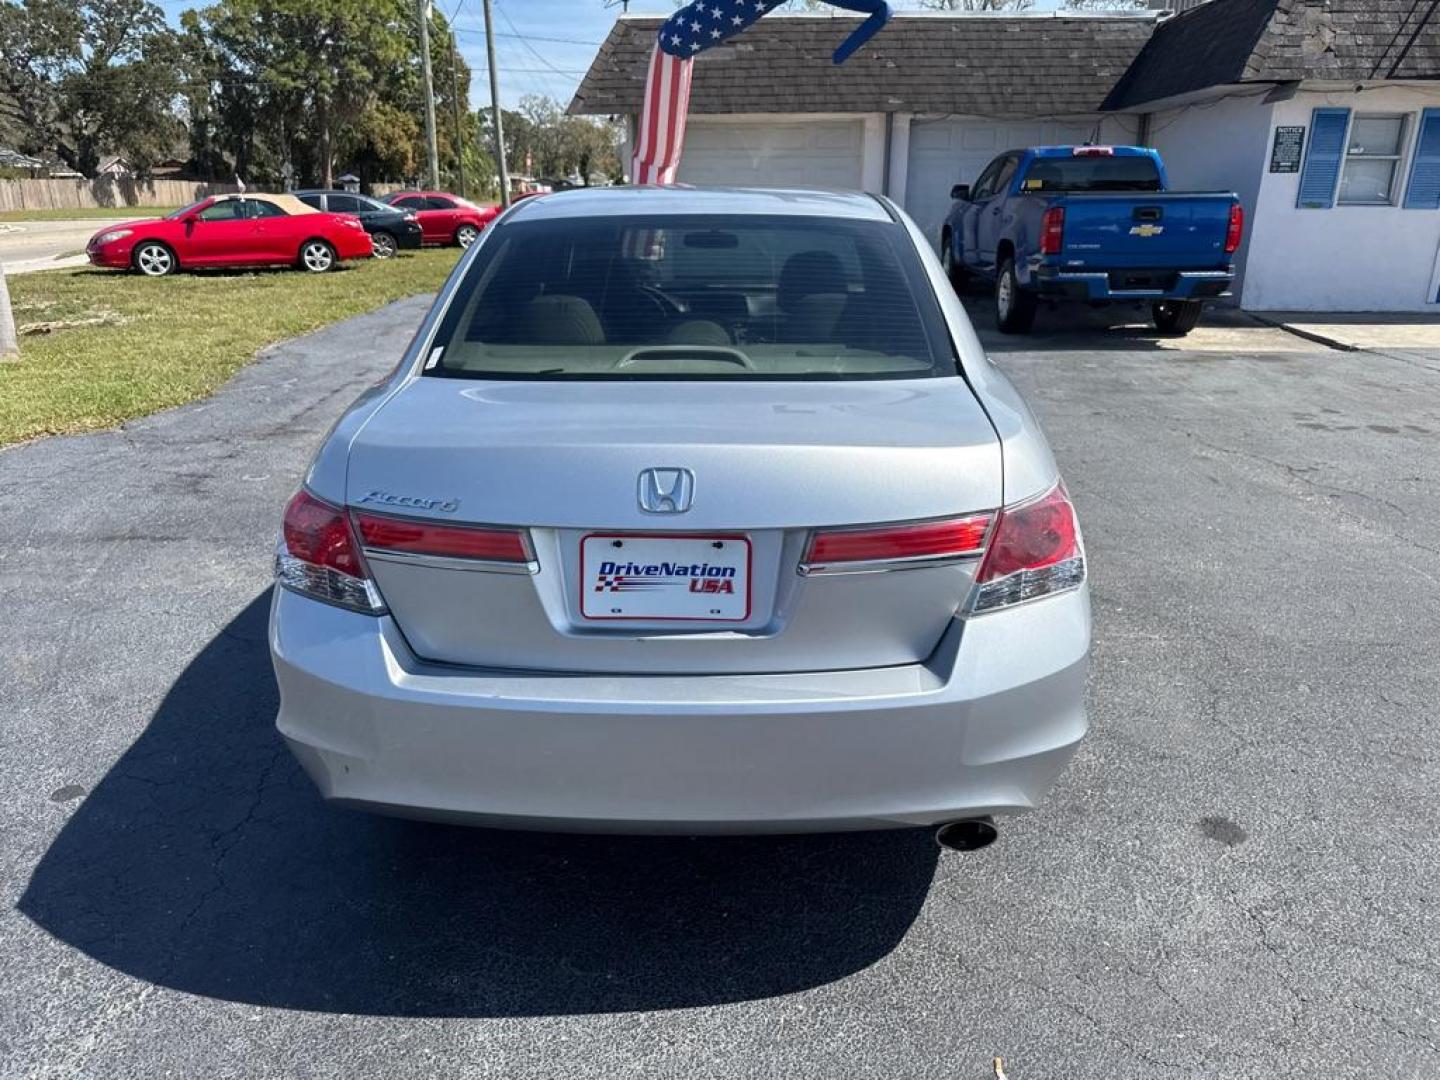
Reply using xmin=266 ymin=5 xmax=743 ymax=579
xmin=426 ymin=216 xmax=956 ymax=379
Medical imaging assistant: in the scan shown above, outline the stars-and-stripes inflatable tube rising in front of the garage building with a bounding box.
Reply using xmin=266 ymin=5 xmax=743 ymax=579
xmin=631 ymin=0 xmax=890 ymax=184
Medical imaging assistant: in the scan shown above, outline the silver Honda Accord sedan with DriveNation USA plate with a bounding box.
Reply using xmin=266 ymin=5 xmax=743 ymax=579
xmin=271 ymin=187 xmax=1090 ymax=835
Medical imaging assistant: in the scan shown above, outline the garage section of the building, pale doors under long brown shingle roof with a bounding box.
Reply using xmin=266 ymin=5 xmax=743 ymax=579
xmin=570 ymin=13 xmax=1155 ymax=247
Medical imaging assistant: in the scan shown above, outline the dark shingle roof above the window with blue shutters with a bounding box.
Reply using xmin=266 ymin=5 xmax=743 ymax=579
xmin=1104 ymin=0 xmax=1440 ymax=109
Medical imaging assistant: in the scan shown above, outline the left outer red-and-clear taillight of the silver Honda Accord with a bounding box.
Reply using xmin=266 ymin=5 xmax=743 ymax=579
xmin=275 ymin=488 xmax=384 ymax=615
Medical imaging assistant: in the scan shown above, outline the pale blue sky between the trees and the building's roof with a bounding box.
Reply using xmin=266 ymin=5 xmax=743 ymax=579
xmin=158 ymin=0 xmax=1082 ymax=116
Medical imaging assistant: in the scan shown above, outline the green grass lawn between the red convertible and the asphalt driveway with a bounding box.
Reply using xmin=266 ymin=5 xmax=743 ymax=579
xmin=0 ymin=248 xmax=459 ymax=445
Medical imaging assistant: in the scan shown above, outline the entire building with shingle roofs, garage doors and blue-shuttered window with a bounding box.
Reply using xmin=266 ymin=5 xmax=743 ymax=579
xmin=570 ymin=0 xmax=1440 ymax=311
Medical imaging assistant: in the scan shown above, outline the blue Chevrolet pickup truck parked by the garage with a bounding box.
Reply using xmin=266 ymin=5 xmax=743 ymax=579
xmin=940 ymin=145 xmax=1244 ymax=334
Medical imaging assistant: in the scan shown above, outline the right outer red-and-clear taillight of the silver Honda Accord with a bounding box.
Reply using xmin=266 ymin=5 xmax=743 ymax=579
xmin=965 ymin=482 xmax=1084 ymax=615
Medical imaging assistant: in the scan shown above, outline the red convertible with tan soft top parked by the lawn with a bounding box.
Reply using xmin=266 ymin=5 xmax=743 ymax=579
xmin=85 ymin=194 xmax=370 ymax=278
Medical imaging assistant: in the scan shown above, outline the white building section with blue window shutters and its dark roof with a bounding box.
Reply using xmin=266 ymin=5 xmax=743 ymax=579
xmin=1106 ymin=0 xmax=1440 ymax=311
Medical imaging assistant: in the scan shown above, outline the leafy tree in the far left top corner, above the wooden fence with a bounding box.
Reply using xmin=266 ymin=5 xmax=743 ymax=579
xmin=0 ymin=0 xmax=183 ymax=176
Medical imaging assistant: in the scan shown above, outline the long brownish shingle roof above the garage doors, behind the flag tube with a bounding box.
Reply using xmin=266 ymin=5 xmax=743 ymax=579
xmin=570 ymin=14 xmax=1155 ymax=117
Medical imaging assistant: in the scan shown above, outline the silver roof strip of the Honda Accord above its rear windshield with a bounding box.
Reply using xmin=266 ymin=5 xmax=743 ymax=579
xmin=508 ymin=184 xmax=890 ymax=222
